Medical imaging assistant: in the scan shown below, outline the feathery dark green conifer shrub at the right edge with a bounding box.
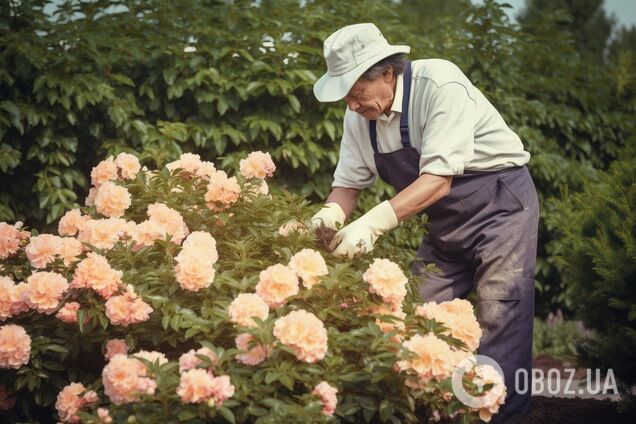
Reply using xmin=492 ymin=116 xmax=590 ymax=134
xmin=554 ymin=146 xmax=636 ymax=398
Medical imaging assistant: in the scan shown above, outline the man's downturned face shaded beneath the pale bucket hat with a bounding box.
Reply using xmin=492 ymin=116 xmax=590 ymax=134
xmin=344 ymin=69 xmax=395 ymax=120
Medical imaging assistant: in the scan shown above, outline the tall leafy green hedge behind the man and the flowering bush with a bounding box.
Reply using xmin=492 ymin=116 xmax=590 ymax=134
xmin=0 ymin=0 xmax=635 ymax=314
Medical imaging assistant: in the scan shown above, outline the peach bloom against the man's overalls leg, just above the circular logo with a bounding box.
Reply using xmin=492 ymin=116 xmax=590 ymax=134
xmin=415 ymin=299 xmax=482 ymax=351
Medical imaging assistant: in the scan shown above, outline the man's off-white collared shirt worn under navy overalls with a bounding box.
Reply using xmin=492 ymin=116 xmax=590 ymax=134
xmin=332 ymin=59 xmax=530 ymax=189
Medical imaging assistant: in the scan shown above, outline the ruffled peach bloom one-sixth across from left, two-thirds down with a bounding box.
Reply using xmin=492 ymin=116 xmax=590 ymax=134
xmin=71 ymin=252 xmax=123 ymax=299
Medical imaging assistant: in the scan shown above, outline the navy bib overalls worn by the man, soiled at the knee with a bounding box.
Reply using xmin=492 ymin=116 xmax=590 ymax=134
xmin=369 ymin=63 xmax=539 ymax=423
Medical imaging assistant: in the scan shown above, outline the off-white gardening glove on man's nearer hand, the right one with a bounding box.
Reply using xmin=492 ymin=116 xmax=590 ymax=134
xmin=331 ymin=200 xmax=398 ymax=259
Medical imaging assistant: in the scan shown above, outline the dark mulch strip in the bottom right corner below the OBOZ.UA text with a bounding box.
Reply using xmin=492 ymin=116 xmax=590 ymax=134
xmin=520 ymin=396 xmax=636 ymax=424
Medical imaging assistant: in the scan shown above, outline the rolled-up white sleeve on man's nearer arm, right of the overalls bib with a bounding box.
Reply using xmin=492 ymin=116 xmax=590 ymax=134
xmin=420 ymin=82 xmax=476 ymax=175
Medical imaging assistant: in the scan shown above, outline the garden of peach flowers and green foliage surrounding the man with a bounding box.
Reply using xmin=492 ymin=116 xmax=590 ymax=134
xmin=0 ymin=0 xmax=636 ymax=423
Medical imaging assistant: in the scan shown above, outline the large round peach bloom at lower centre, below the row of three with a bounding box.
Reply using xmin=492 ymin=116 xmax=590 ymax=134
xmin=274 ymin=309 xmax=327 ymax=363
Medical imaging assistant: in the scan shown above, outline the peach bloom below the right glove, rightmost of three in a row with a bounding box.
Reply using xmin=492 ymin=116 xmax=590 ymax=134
xmin=362 ymin=259 xmax=408 ymax=305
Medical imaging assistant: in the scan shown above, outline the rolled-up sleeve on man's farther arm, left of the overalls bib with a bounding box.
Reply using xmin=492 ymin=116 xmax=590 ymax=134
xmin=332 ymin=112 xmax=376 ymax=190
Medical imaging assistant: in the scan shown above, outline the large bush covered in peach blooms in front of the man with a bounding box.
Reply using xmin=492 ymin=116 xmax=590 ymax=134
xmin=0 ymin=152 xmax=503 ymax=423
